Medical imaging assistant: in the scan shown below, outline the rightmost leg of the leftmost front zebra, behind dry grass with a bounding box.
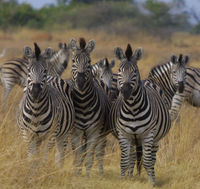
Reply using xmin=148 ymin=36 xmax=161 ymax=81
xmin=55 ymin=136 xmax=68 ymax=168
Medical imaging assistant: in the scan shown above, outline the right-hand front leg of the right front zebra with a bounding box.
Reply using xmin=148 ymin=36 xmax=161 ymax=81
xmin=142 ymin=132 xmax=155 ymax=185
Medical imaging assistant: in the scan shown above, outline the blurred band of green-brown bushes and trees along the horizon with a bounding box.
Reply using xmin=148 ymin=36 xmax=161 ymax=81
xmin=0 ymin=0 xmax=189 ymax=35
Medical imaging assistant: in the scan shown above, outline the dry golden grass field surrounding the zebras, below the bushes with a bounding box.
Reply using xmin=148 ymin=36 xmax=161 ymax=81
xmin=0 ymin=29 xmax=200 ymax=189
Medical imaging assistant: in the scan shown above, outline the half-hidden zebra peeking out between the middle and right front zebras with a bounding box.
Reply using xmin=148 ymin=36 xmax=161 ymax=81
xmin=92 ymin=58 xmax=119 ymax=102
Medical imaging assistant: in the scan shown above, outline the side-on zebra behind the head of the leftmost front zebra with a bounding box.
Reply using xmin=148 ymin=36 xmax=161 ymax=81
xmin=0 ymin=43 xmax=69 ymax=106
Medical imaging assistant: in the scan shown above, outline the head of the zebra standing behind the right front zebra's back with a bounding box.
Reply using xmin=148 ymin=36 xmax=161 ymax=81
xmin=171 ymin=54 xmax=189 ymax=93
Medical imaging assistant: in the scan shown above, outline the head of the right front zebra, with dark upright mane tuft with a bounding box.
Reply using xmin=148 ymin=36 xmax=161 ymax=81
xmin=115 ymin=44 xmax=142 ymax=100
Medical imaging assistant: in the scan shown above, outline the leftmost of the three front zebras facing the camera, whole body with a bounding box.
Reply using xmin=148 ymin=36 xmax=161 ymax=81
xmin=17 ymin=43 xmax=74 ymax=167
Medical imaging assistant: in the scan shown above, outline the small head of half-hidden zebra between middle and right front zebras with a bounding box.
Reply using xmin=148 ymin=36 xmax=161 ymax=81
xmin=97 ymin=58 xmax=115 ymax=89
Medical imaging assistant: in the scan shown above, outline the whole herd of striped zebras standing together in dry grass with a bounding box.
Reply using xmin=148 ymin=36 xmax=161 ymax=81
xmin=0 ymin=38 xmax=200 ymax=185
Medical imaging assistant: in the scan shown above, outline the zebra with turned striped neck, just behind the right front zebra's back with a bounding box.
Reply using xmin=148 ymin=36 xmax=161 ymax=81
xmin=147 ymin=54 xmax=189 ymax=121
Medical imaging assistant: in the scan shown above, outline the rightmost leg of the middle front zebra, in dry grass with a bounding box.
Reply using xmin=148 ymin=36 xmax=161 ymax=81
xmin=95 ymin=137 xmax=107 ymax=175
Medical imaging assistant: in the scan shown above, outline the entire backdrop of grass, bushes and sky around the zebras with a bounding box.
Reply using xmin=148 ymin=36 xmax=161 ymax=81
xmin=0 ymin=0 xmax=200 ymax=189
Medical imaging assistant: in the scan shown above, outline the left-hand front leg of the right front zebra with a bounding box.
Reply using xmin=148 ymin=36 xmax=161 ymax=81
xmin=118 ymin=134 xmax=131 ymax=179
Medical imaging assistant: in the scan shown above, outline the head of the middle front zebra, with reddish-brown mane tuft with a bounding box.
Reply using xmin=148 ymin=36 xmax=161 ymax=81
xmin=70 ymin=38 xmax=95 ymax=90
